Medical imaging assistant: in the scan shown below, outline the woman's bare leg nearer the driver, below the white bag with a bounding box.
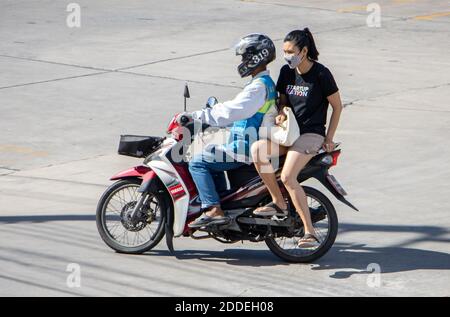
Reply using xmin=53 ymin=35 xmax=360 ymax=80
xmin=251 ymin=140 xmax=287 ymax=210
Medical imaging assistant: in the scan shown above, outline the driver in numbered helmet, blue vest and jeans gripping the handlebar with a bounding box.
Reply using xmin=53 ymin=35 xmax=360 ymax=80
xmin=185 ymin=34 xmax=277 ymax=228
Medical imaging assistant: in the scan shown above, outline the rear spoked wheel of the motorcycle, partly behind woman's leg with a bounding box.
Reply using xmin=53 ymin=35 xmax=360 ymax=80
xmin=266 ymin=186 xmax=338 ymax=263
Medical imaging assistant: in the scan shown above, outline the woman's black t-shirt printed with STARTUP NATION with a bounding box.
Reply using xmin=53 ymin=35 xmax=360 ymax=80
xmin=277 ymin=62 xmax=338 ymax=136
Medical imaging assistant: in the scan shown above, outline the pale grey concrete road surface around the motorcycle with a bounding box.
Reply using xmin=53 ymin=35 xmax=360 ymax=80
xmin=0 ymin=0 xmax=450 ymax=296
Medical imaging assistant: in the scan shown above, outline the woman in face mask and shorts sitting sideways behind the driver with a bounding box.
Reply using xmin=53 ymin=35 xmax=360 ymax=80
xmin=251 ymin=28 xmax=342 ymax=248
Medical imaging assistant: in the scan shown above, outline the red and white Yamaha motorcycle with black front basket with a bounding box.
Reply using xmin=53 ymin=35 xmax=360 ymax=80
xmin=96 ymin=91 xmax=358 ymax=263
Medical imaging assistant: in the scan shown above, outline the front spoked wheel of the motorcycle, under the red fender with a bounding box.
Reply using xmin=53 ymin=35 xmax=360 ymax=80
xmin=97 ymin=179 xmax=167 ymax=253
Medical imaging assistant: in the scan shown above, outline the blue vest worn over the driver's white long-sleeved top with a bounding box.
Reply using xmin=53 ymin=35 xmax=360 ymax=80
xmin=226 ymin=75 xmax=277 ymax=157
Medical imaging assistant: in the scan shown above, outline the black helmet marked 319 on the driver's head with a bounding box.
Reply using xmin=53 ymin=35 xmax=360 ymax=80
xmin=235 ymin=33 xmax=275 ymax=77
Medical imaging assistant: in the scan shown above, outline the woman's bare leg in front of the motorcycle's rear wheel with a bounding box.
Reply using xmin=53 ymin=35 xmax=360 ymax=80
xmin=281 ymin=151 xmax=315 ymax=235
